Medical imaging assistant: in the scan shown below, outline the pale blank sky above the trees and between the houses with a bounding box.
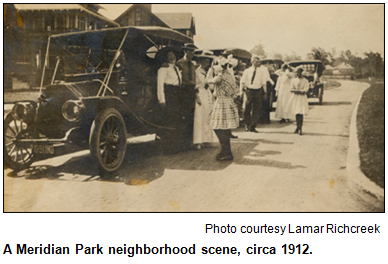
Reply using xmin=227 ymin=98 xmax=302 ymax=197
xmin=98 ymin=4 xmax=384 ymax=58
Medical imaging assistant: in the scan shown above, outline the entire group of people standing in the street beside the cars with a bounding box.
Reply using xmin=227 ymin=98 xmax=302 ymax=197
xmin=157 ymin=43 xmax=309 ymax=161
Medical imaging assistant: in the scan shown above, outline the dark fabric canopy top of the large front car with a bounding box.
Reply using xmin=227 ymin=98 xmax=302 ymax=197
xmin=51 ymin=27 xmax=193 ymax=54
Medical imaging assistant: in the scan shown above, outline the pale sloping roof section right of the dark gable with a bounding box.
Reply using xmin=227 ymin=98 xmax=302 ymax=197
xmin=155 ymin=13 xmax=196 ymax=37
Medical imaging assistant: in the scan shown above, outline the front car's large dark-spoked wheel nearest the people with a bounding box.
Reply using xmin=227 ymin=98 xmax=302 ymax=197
xmin=89 ymin=108 xmax=127 ymax=173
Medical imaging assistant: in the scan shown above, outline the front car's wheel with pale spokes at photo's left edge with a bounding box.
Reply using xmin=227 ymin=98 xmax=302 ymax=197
xmin=4 ymin=113 xmax=34 ymax=171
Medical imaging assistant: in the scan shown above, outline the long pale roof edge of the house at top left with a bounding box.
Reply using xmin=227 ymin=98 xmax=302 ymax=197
xmin=14 ymin=4 xmax=120 ymax=27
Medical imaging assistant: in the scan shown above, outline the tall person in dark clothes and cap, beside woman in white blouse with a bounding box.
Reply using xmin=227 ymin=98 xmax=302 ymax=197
xmin=177 ymin=43 xmax=197 ymax=151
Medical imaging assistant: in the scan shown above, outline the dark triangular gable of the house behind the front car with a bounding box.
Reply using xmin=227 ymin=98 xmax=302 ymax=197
xmin=115 ymin=4 xmax=169 ymax=28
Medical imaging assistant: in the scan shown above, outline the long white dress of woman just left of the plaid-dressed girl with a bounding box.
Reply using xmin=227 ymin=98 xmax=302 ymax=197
xmin=193 ymin=67 xmax=218 ymax=144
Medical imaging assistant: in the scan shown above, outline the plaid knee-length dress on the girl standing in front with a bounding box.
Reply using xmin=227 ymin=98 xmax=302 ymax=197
xmin=211 ymin=70 xmax=239 ymax=130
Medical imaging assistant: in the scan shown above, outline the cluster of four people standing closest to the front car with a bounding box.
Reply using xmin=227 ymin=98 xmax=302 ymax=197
xmin=157 ymin=43 xmax=239 ymax=161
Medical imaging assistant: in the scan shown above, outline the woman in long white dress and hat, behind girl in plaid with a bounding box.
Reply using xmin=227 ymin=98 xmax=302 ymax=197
xmin=193 ymin=51 xmax=217 ymax=149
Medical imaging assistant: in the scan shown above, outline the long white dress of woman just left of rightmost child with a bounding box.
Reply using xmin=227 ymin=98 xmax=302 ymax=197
xmin=275 ymin=70 xmax=294 ymax=119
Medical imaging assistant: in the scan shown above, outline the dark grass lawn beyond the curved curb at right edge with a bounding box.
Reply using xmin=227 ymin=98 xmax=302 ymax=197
xmin=357 ymin=82 xmax=385 ymax=188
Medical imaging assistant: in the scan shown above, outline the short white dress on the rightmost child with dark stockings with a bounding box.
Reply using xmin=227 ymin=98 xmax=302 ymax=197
xmin=287 ymin=77 xmax=309 ymax=115
